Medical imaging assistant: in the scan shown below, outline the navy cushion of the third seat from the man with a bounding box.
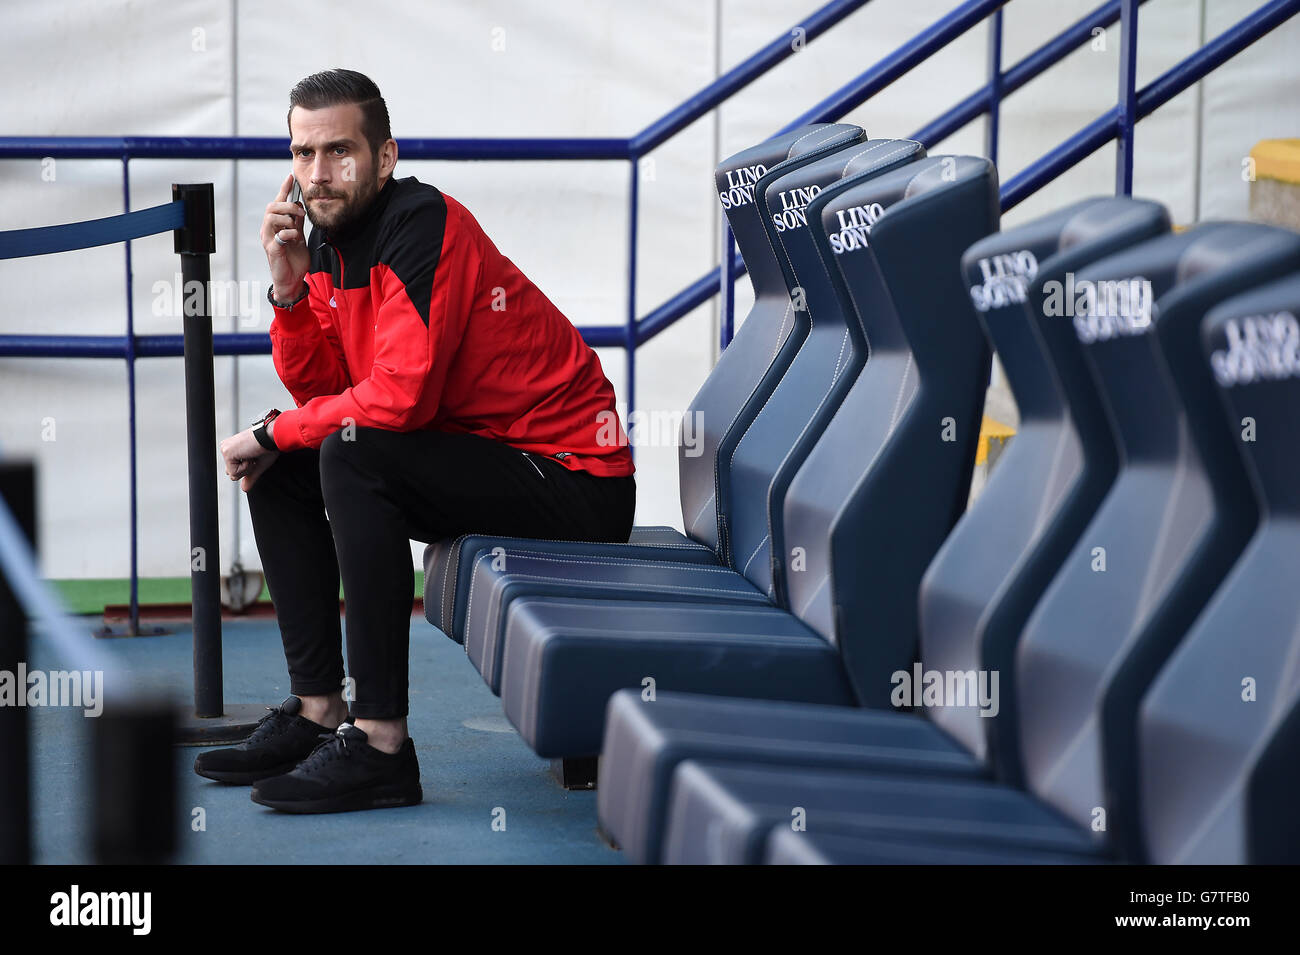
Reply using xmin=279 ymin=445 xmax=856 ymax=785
xmin=502 ymin=596 xmax=854 ymax=758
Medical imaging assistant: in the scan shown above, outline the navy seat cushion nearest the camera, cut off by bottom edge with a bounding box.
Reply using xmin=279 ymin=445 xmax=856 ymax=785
xmin=763 ymin=826 xmax=1106 ymax=865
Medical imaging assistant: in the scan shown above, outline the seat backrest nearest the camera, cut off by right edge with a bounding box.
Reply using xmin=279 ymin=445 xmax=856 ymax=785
xmin=1138 ymin=274 xmax=1300 ymax=865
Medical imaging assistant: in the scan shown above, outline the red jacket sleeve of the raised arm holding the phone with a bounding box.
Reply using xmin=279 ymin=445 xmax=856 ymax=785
xmin=270 ymin=277 xmax=352 ymax=405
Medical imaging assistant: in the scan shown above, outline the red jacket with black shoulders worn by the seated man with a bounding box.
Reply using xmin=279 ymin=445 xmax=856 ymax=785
xmin=270 ymin=177 xmax=633 ymax=477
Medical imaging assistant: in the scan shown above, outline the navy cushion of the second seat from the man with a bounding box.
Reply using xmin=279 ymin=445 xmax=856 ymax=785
xmin=462 ymin=546 xmax=771 ymax=695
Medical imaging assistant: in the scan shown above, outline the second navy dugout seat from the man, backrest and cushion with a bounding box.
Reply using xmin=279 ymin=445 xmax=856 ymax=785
xmin=463 ymin=140 xmax=923 ymax=693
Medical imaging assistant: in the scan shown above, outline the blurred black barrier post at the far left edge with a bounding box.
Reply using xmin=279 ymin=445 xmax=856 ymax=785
xmin=0 ymin=461 xmax=36 ymax=865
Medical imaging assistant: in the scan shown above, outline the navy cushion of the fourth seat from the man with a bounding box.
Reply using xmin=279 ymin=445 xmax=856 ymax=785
xmin=597 ymin=690 xmax=984 ymax=864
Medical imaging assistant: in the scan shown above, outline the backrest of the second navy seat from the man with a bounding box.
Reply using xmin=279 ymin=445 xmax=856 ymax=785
xmin=718 ymin=139 xmax=924 ymax=596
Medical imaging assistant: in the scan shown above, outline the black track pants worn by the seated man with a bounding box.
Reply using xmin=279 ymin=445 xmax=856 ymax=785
xmin=248 ymin=427 xmax=636 ymax=719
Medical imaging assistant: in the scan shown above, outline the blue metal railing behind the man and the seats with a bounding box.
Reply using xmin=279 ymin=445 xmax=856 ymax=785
xmin=0 ymin=0 xmax=1300 ymax=624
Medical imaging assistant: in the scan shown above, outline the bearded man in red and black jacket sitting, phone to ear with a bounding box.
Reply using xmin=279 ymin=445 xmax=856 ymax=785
xmin=195 ymin=70 xmax=636 ymax=812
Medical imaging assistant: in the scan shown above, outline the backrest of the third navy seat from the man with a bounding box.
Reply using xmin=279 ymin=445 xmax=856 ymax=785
xmin=783 ymin=156 xmax=998 ymax=706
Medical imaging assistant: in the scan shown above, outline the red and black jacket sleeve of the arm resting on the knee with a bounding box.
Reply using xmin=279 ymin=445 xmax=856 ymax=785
xmin=272 ymin=201 xmax=482 ymax=451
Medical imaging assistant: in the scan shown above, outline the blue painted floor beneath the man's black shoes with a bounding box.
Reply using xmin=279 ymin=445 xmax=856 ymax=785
xmin=29 ymin=617 xmax=623 ymax=864
